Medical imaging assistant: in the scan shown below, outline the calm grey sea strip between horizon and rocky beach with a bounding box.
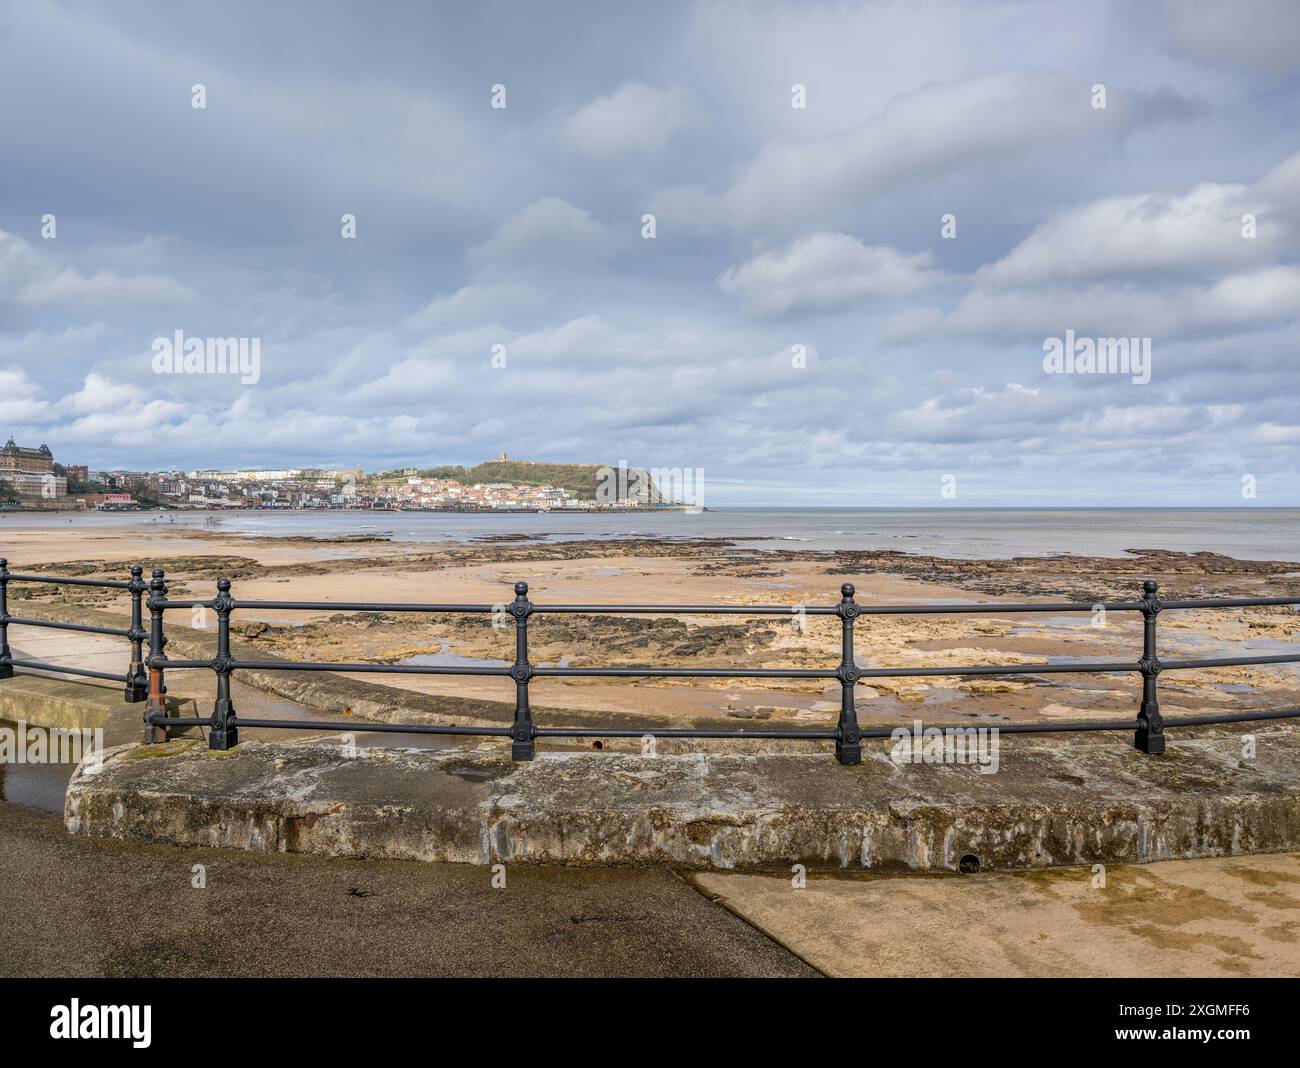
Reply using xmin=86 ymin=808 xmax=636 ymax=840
xmin=0 ymin=507 xmax=1300 ymax=563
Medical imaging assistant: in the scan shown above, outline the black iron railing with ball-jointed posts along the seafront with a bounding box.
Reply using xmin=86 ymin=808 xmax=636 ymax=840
xmin=0 ymin=560 xmax=1300 ymax=764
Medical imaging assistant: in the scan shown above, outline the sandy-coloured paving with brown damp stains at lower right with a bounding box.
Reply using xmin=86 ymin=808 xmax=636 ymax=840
xmin=690 ymin=854 xmax=1300 ymax=980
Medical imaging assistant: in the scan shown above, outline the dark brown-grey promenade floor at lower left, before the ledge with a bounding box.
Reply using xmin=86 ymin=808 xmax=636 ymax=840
xmin=0 ymin=803 xmax=816 ymax=977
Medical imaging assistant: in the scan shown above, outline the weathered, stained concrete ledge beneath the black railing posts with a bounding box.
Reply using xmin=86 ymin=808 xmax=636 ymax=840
xmin=65 ymin=730 xmax=1300 ymax=871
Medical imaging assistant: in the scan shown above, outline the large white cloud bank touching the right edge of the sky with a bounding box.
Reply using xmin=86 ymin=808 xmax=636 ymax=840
xmin=887 ymin=153 xmax=1300 ymax=342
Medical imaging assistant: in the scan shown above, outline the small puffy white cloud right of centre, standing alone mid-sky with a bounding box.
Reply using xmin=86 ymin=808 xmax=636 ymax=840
xmin=718 ymin=233 xmax=943 ymax=317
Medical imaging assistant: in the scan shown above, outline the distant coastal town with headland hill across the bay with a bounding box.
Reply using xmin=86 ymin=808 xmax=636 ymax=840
xmin=0 ymin=438 xmax=675 ymax=512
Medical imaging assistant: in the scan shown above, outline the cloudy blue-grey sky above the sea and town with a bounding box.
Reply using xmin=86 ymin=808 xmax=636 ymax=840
xmin=0 ymin=0 xmax=1300 ymax=507
